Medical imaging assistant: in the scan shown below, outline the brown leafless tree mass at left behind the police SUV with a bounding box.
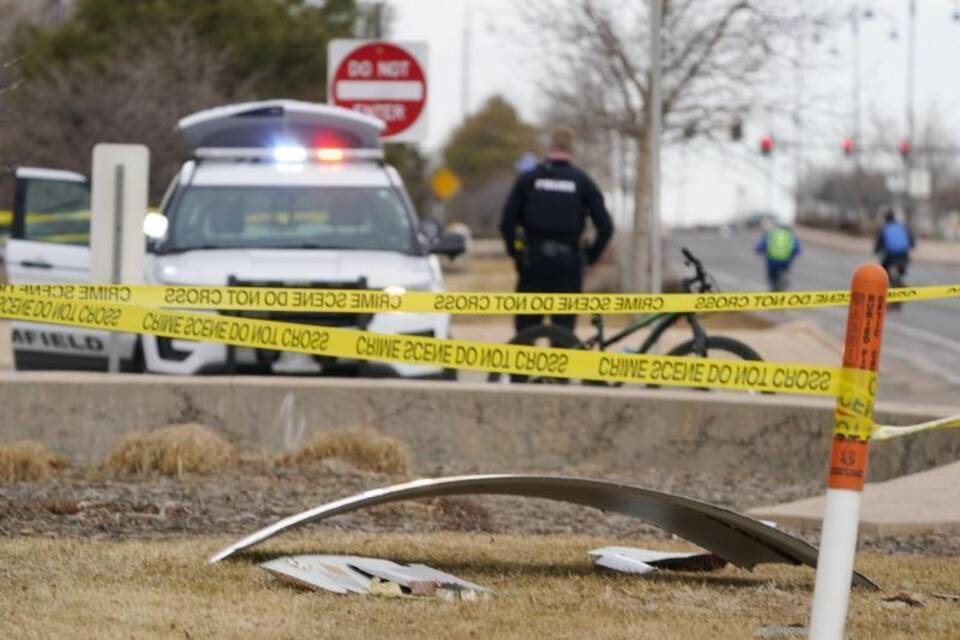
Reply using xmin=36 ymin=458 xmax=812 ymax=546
xmin=0 ymin=27 xmax=239 ymax=200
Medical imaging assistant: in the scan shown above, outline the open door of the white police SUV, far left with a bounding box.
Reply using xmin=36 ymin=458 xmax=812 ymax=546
xmin=6 ymin=167 xmax=117 ymax=369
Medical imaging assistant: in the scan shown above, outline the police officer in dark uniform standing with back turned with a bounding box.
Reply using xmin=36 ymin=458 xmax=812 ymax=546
xmin=500 ymin=127 xmax=613 ymax=331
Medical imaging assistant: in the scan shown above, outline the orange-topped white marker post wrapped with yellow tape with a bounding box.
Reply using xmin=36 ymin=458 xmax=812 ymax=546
xmin=809 ymin=264 xmax=888 ymax=640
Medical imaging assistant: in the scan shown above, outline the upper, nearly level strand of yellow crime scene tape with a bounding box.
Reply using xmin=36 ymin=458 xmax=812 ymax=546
xmin=2 ymin=284 xmax=960 ymax=315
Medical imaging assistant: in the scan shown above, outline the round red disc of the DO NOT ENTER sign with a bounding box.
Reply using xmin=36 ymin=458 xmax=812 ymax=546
xmin=330 ymin=42 xmax=427 ymax=137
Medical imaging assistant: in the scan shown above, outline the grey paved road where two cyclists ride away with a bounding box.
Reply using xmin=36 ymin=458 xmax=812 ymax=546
xmin=669 ymin=231 xmax=960 ymax=385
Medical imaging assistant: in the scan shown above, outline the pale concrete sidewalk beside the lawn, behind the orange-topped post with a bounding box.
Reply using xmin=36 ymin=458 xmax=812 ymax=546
xmin=748 ymin=460 xmax=960 ymax=536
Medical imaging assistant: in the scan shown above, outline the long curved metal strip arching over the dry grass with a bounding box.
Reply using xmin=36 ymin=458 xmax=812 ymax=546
xmin=208 ymin=474 xmax=877 ymax=589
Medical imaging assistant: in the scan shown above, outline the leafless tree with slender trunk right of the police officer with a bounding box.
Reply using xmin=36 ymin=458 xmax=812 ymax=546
xmin=530 ymin=0 xmax=823 ymax=290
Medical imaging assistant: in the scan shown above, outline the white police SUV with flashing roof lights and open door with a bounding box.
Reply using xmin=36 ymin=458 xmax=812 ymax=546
xmin=6 ymin=100 xmax=464 ymax=377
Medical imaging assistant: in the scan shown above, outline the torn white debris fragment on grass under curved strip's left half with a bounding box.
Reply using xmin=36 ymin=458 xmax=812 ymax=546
xmin=260 ymin=555 xmax=490 ymax=600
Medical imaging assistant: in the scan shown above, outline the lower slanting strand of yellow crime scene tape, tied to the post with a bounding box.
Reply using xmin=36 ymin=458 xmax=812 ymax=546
xmin=0 ymin=287 xmax=871 ymax=396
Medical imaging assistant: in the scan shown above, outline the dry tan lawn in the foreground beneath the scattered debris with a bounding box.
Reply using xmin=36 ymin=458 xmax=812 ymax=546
xmin=0 ymin=528 xmax=960 ymax=640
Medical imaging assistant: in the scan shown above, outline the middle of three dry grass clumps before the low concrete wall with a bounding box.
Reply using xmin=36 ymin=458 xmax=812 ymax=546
xmin=101 ymin=424 xmax=237 ymax=477
